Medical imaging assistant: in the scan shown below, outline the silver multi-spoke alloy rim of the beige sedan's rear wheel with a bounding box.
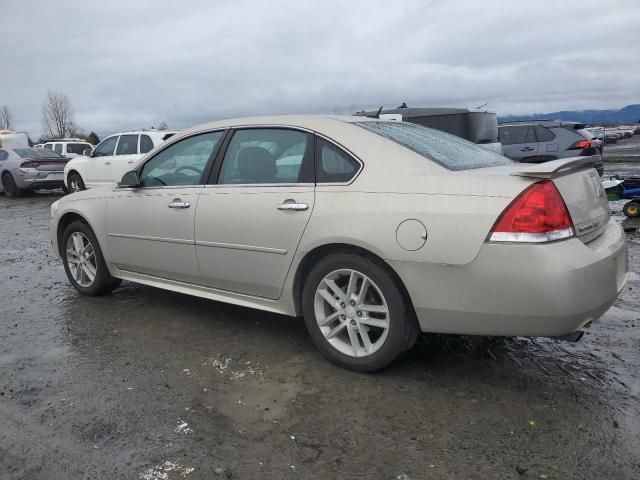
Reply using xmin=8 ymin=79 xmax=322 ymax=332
xmin=314 ymin=269 xmax=390 ymax=357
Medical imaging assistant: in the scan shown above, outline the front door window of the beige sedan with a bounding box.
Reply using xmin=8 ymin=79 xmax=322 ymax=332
xmin=140 ymin=132 xmax=223 ymax=187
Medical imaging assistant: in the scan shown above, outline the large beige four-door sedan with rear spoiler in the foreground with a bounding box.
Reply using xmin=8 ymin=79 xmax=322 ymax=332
xmin=51 ymin=116 xmax=628 ymax=371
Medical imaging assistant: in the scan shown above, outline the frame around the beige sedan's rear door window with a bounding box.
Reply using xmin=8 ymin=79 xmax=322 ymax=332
xmin=206 ymin=125 xmax=315 ymax=188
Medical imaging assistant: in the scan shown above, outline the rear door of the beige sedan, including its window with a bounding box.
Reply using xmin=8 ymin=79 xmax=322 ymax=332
xmin=195 ymin=128 xmax=314 ymax=299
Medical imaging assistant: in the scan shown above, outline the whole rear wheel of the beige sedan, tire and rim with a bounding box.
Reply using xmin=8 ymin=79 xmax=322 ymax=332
xmin=303 ymin=254 xmax=419 ymax=372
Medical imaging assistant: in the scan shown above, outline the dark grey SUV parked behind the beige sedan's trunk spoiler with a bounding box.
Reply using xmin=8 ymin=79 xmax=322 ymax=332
xmin=498 ymin=120 xmax=604 ymax=176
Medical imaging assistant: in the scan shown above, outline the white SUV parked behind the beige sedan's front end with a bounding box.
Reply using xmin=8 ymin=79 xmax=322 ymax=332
xmin=64 ymin=130 xmax=176 ymax=192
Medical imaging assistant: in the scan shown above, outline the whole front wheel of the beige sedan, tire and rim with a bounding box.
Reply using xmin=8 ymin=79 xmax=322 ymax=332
xmin=62 ymin=221 xmax=121 ymax=296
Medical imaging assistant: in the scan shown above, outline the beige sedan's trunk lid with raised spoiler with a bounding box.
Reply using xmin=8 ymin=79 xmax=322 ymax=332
xmin=511 ymin=157 xmax=611 ymax=243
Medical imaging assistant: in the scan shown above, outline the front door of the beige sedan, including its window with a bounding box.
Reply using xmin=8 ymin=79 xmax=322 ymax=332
xmin=106 ymin=131 xmax=224 ymax=283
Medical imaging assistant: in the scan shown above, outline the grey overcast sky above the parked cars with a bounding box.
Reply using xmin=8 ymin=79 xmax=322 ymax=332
xmin=0 ymin=0 xmax=640 ymax=138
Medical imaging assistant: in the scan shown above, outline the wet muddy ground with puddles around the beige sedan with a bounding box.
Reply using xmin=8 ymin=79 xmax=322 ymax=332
xmin=0 ymin=166 xmax=640 ymax=480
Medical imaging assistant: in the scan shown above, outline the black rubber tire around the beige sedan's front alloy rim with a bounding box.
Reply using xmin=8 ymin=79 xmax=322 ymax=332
xmin=59 ymin=220 xmax=122 ymax=297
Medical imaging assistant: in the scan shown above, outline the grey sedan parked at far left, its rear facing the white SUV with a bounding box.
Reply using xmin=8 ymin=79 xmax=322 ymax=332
xmin=0 ymin=147 xmax=69 ymax=197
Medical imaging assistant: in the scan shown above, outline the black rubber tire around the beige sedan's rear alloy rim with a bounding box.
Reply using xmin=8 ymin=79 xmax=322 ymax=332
xmin=302 ymin=253 xmax=420 ymax=372
